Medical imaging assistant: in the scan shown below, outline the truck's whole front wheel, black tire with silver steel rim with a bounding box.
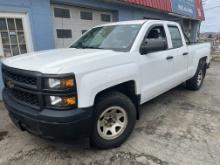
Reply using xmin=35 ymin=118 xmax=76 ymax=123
xmin=91 ymin=92 xmax=136 ymax=149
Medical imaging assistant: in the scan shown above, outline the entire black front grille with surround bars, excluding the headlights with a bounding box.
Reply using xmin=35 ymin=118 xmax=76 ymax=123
xmin=2 ymin=64 xmax=76 ymax=111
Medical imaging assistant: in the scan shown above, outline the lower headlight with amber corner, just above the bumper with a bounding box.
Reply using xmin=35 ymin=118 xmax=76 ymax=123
xmin=49 ymin=96 xmax=77 ymax=108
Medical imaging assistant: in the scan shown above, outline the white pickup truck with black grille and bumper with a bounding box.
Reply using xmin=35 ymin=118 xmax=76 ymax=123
xmin=2 ymin=20 xmax=211 ymax=149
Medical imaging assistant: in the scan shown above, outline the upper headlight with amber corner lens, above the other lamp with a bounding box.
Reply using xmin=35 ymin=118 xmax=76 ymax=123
xmin=46 ymin=78 xmax=75 ymax=90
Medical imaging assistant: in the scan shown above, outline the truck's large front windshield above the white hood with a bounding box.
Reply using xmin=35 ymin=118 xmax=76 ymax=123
xmin=71 ymin=24 xmax=141 ymax=51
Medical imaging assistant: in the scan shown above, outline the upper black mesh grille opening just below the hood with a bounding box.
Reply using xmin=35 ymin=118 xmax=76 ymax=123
xmin=3 ymin=69 xmax=37 ymax=86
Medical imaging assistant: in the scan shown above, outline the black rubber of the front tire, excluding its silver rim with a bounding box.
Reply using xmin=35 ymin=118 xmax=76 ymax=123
xmin=91 ymin=92 xmax=136 ymax=149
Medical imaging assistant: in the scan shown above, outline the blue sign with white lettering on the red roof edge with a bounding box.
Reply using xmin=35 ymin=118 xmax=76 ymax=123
xmin=171 ymin=0 xmax=196 ymax=18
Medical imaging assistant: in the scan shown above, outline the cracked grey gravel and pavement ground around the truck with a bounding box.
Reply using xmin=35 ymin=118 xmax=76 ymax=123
xmin=0 ymin=63 xmax=220 ymax=165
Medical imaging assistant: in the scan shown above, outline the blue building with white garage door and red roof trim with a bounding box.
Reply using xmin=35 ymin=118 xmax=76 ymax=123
xmin=0 ymin=0 xmax=204 ymax=97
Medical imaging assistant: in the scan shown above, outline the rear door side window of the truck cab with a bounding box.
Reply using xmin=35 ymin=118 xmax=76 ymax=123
xmin=168 ymin=26 xmax=183 ymax=49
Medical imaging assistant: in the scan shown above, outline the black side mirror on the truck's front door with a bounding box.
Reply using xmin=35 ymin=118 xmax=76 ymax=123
xmin=140 ymin=38 xmax=167 ymax=55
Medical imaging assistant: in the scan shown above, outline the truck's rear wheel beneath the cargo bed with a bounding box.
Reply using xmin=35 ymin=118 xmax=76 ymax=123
xmin=186 ymin=60 xmax=206 ymax=91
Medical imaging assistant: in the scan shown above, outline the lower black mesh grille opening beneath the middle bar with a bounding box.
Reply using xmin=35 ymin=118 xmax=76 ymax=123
xmin=10 ymin=89 xmax=40 ymax=107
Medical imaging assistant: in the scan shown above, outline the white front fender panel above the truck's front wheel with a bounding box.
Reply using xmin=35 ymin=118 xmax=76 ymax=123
xmin=76 ymin=63 xmax=141 ymax=108
